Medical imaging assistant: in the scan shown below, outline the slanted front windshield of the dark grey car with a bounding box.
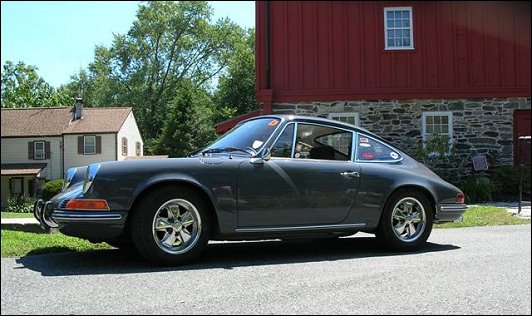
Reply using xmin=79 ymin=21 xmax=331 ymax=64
xmin=205 ymin=118 xmax=281 ymax=151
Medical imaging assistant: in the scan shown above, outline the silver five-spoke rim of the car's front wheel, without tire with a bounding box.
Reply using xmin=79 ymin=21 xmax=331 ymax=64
xmin=152 ymin=199 xmax=201 ymax=255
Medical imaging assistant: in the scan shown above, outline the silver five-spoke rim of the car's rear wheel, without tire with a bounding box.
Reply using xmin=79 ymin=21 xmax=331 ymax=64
xmin=391 ymin=197 xmax=427 ymax=242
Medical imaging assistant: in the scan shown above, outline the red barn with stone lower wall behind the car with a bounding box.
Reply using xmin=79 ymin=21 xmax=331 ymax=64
xmin=217 ymin=1 xmax=531 ymax=173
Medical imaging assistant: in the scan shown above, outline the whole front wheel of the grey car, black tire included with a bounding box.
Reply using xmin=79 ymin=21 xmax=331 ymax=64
xmin=131 ymin=186 xmax=213 ymax=265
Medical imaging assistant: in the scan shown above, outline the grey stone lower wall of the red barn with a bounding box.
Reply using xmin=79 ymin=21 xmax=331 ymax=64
xmin=272 ymin=98 xmax=530 ymax=174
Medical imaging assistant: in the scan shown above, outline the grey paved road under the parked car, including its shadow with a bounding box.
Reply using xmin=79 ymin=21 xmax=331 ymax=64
xmin=1 ymin=225 xmax=531 ymax=315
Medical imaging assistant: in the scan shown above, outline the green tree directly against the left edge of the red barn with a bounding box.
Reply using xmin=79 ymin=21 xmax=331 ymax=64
xmin=214 ymin=29 xmax=257 ymax=122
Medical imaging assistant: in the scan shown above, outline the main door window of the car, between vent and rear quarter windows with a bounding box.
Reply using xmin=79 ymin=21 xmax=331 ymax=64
xmin=294 ymin=124 xmax=353 ymax=160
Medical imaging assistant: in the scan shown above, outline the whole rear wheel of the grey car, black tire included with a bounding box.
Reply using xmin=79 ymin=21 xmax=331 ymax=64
xmin=375 ymin=190 xmax=434 ymax=251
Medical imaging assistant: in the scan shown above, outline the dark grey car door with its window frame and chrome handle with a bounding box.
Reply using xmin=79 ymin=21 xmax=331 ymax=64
xmin=237 ymin=123 xmax=360 ymax=227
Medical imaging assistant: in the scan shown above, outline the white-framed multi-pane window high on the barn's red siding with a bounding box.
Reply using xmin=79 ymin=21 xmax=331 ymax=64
xmin=384 ymin=7 xmax=414 ymax=50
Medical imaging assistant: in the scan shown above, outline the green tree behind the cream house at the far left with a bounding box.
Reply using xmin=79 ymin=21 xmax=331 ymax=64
xmin=1 ymin=61 xmax=68 ymax=108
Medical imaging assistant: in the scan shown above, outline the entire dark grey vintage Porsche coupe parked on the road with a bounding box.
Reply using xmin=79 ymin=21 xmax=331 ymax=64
xmin=35 ymin=115 xmax=467 ymax=264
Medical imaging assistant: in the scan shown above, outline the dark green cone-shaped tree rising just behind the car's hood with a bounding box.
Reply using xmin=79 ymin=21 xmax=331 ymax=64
xmin=153 ymin=81 xmax=216 ymax=157
